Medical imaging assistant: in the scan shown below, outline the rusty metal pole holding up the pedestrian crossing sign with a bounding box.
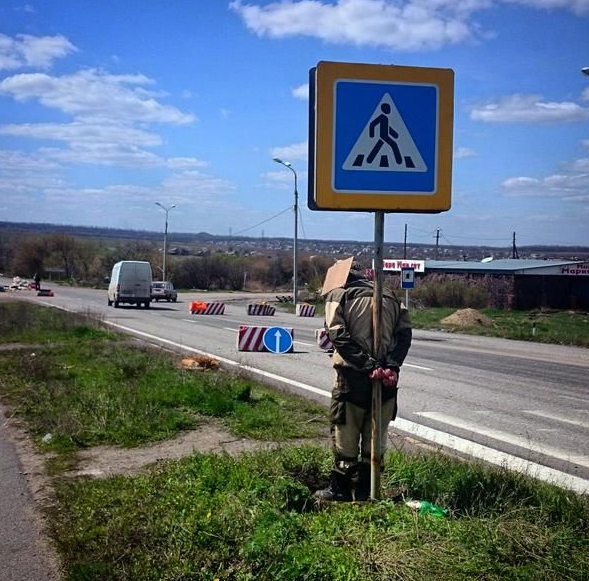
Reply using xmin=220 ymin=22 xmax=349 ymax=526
xmin=370 ymin=211 xmax=384 ymax=500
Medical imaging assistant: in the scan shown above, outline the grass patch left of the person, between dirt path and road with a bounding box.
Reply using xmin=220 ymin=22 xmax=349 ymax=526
xmin=0 ymin=305 xmax=327 ymax=453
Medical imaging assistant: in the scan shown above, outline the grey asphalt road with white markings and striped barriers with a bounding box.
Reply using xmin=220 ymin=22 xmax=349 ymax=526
xmin=0 ymin=280 xmax=589 ymax=492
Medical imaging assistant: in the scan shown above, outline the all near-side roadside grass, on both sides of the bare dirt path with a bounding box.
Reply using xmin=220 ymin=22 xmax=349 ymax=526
xmin=0 ymin=304 xmax=589 ymax=581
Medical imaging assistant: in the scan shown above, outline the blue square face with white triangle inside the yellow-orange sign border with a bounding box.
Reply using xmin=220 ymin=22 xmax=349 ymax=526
xmin=333 ymin=79 xmax=439 ymax=195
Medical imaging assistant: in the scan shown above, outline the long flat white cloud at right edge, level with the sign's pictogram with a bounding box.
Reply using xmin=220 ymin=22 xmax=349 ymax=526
xmin=470 ymin=94 xmax=589 ymax=123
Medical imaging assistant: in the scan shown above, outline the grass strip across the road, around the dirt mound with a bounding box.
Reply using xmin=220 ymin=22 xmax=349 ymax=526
xmin=411 ymin=307 xmax=589 ymax=347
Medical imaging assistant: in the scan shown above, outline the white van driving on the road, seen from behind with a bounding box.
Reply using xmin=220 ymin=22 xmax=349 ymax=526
xmin=108 ymin=260 xmax=152 ymax=309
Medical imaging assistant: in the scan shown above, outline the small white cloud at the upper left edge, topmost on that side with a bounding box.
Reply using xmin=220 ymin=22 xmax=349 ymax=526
xmin=0 ymin=33 xmax=77 ymax=70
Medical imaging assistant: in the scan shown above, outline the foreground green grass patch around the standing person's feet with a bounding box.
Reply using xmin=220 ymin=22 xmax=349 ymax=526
xmin=53 ymin=446 xmax=589 ymax=581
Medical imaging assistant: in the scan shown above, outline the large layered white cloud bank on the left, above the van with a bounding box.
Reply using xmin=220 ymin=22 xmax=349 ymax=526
xmin=0 ymin=64 xmax=200 ymax=169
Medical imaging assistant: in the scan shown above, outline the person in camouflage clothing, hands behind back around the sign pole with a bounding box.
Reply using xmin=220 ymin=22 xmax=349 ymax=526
xmin=314 ymin=263 xmax=412 ymax=501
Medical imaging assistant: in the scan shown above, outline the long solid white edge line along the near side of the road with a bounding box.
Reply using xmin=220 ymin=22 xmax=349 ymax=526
xmin=90 ymin=322 xmax=589 ymax=494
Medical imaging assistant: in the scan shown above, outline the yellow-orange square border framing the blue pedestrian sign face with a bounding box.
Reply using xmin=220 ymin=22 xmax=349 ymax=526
xmin=314 ymin=61 xmax=454 ymax=213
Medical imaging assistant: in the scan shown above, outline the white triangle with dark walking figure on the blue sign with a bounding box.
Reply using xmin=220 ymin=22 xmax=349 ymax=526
xmin=342 ymin=93 xmax=427 ymax=172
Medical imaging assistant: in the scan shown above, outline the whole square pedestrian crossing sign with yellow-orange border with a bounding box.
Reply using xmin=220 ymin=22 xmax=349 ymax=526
xmin=309 ymin=61 xmax=454 ymax=213
